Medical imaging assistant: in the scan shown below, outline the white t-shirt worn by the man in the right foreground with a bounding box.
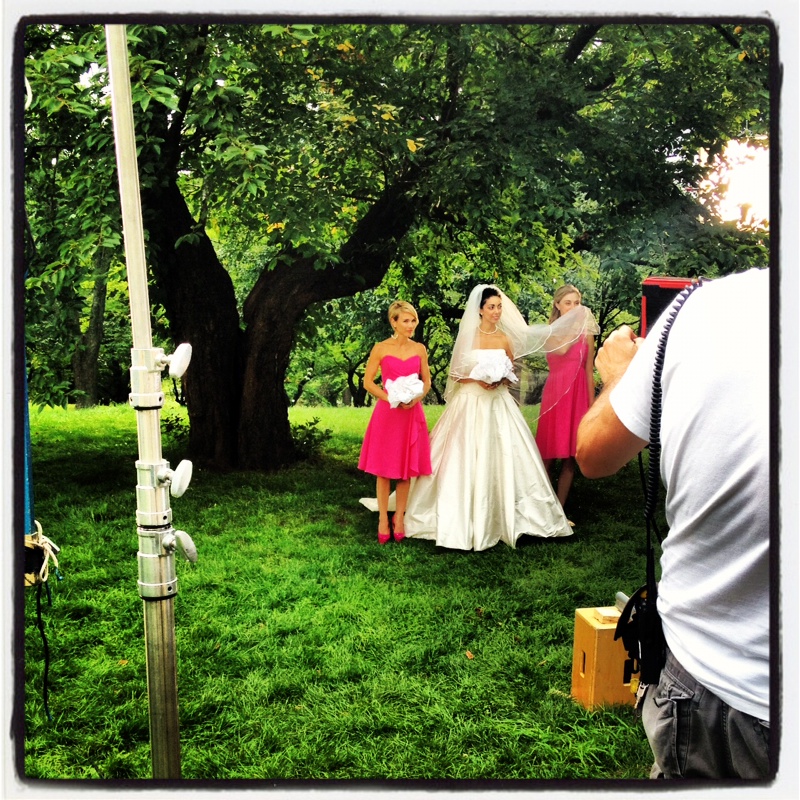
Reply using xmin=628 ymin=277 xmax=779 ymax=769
xmin=609 ymin=269 xmax=777 ymax=720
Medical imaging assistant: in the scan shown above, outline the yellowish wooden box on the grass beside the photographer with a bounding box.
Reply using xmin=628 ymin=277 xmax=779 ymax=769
xmin=572 ymin=607 xmax=636 ymax=708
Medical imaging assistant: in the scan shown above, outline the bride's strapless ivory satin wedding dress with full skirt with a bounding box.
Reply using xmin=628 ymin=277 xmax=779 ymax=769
xmin=404 ymin=349 xmax=572 ymax=550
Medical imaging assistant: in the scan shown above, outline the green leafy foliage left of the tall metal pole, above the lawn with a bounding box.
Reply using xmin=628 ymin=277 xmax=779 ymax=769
xmin=25 ymin=25 xmax=130 ymax=404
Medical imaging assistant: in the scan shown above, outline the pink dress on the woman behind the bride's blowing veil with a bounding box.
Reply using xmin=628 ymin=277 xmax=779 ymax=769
xmin=536 ymin=337 xmax=589 ymax=459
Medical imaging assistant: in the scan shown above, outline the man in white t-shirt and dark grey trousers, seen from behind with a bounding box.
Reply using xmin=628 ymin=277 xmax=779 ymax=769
xmin=577 ymin=270 xmax=774 ymax=778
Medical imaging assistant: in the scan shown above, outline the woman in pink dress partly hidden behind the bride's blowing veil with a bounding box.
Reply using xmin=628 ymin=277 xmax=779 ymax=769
xmin=536 ymin=284 xmax=595 ymax=524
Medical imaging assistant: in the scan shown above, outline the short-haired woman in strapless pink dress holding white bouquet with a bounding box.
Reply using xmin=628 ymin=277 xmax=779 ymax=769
xmin=358 ymin=301 xmax=431 ymax=544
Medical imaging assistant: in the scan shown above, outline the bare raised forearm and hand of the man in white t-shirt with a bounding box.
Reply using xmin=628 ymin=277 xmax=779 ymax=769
xmin=576 ymin=326 xmax=647 ymax=478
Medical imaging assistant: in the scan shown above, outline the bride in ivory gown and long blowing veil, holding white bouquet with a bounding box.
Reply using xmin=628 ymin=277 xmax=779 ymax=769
xmin=394 ymin=284 xmax=594 ymax=550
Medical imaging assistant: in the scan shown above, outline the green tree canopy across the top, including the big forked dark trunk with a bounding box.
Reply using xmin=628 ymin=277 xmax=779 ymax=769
xmin=23 ymin=22 xmax=772 ymax=469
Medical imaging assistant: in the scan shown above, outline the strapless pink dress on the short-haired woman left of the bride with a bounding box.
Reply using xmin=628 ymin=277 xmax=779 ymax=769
xmin=358 ymin=355 xmax=431 ymax=480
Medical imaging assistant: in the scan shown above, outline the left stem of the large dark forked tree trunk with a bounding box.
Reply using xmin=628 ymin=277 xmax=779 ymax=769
xmin=142 ymin=182 xmax=242 ymax=469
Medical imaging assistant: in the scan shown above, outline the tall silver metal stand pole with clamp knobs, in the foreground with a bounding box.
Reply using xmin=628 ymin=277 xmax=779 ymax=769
xmin=106 ymin=25 xmax=194 ymax=778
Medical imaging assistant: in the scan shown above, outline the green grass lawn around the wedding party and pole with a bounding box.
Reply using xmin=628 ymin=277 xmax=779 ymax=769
xmin=24 ymin=406 xmax=650 ymax=780
